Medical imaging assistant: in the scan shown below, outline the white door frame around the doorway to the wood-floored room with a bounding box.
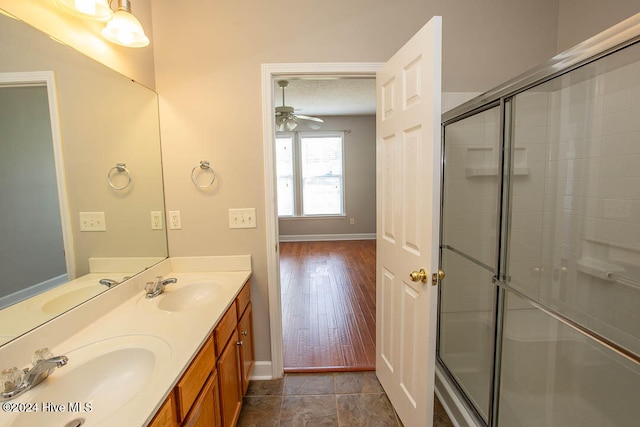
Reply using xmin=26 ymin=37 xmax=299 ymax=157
xmin=256 ymin=62 xmax=382 ymax=378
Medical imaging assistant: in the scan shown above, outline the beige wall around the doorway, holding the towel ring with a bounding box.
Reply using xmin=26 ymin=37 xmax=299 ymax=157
xmin=152 ymin=0 xmax=557 ymax=360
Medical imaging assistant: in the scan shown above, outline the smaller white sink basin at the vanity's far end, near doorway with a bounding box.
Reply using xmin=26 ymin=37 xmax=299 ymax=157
xmin=138 ymin=281 xmax=220 ymax=312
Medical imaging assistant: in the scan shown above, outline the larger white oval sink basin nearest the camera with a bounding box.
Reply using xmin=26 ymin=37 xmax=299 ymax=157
xmin=9 ymin=335 xmax=171 ymax=427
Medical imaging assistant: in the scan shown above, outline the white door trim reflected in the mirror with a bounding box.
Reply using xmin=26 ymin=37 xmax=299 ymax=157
xmin=0 ymin=71 xmax=76 ymax=280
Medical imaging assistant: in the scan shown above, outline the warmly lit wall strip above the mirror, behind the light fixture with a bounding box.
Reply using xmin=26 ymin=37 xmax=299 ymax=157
xmin=0 ymin=0 xmax=155 ymax=89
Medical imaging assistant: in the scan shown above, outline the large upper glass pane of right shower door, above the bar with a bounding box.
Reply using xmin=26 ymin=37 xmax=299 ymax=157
xmin=507 ymin=44 xmax=640 ymax=358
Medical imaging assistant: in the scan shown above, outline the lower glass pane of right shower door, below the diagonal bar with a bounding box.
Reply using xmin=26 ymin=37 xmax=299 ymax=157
xmin=498 ymin=292 xmax=640 ymax=427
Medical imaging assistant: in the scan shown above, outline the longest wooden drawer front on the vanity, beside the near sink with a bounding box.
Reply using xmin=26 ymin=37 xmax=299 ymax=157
xmin=176 ymin=337 xmax=216 ymax=422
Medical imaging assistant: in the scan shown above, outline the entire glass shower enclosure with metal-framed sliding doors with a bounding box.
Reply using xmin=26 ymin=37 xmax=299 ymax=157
xmin=437 ymin=14 xmax=640 ymax=427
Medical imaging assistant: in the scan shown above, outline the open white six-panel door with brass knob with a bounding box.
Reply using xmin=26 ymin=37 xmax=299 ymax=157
xmin=376 ymin=17 xmax=442 ymax=427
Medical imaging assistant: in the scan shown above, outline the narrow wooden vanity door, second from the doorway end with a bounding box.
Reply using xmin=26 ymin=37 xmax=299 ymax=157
xmin=217 ymin=330 xmax=242 ymax=427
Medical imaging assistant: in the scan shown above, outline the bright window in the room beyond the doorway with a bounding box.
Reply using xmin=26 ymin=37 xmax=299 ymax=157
xmin=276 ymin=132 xmax=344 ymax=217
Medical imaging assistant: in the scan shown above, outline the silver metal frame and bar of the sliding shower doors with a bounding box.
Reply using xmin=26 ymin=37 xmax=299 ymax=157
xmin=436 ymin=13 xmax=640 ymax=427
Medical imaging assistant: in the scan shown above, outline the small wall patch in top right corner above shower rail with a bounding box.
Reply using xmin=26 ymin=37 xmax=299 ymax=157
xmin=558 ymin=0 xmax=640 ymax=52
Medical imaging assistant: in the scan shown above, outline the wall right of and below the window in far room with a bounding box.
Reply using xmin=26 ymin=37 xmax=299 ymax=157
xmin=279 ymin=116 xmax=376 ymax=237
